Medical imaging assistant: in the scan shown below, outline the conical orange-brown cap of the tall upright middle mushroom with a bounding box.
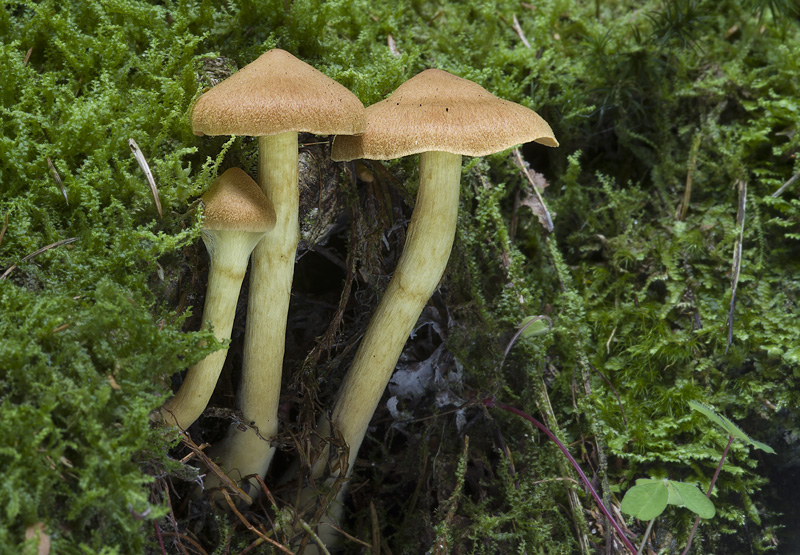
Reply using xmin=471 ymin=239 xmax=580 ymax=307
xmin=192 ymin=49 xmax=364 ymax=137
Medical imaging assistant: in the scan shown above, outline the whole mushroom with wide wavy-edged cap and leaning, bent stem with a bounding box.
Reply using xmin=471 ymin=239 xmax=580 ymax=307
xmin=313 ymin=69 xmax=558 ymax=486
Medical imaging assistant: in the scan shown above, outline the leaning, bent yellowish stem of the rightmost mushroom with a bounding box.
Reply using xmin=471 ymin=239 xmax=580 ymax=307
xmin=313 ymin=152 xmax=461 ymax=477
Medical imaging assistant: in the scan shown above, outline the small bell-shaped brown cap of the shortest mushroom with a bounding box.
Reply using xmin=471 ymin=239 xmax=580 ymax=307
xmin=203 ymin=168 xmax=275 ymax=233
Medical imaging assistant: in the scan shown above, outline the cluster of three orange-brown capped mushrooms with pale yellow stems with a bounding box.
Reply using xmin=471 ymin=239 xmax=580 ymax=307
xmin=161 ymin=49 xmax=558 ymax=548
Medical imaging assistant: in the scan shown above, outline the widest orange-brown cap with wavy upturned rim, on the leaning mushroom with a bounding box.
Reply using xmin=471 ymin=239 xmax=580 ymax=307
xmin=331 ymin=69 xmax=558 ymax=161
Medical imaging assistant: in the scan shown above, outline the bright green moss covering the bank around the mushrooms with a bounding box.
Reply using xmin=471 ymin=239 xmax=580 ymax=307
xmin=0 ymin=0 xmax=800 ymax=553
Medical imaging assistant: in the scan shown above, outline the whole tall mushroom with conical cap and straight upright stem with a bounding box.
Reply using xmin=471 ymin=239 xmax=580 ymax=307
xmin=191 ymin=49 xmax=364 ymax=496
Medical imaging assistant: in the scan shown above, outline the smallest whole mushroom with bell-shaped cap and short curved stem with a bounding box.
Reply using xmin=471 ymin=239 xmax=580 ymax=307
xmin=161 ymin=168 xmax=275 ymax=429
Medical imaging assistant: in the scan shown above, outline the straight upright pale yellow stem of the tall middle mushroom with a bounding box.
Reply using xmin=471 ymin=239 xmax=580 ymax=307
xmin=216 ymin=131 xmax=300 ymax=496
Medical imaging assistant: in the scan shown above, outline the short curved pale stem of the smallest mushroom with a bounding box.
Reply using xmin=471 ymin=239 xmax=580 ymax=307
xmin=161 ymin=229 xmax=264 ymax=430
